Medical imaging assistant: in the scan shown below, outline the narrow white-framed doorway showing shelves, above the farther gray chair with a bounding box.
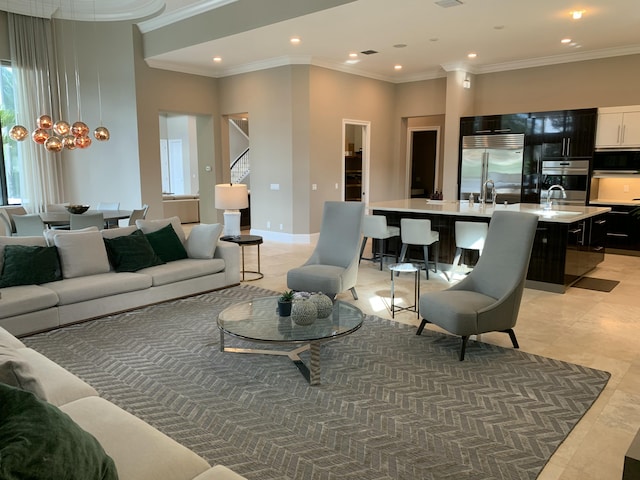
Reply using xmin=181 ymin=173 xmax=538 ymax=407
xmin=342 ymin=119 xmax=371 ymax=208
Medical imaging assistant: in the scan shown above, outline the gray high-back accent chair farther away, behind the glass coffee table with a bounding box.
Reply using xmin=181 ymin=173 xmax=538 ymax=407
xmin=287 ymin=202 xmax=364 ymax=300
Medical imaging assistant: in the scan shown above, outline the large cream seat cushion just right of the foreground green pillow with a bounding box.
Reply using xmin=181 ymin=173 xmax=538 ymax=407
xmin=60 ymin=397 xmax=209 ymax=480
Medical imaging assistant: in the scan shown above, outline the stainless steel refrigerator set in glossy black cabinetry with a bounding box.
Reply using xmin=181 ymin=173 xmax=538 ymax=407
xmin=458 ymin=133 xmax=524 ymax=203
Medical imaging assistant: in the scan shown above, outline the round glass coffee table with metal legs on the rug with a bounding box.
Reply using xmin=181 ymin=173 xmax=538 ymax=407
xmin=218 ymin=296 xmax=364 ymax=385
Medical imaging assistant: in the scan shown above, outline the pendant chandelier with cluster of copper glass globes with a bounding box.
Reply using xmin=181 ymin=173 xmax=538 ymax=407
xmin=9 ymin=0 xmax=111 ymax=153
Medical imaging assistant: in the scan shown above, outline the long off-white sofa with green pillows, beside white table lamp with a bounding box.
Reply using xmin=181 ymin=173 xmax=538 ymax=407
xmin=0 ymin=217 xmax=240 ymax=336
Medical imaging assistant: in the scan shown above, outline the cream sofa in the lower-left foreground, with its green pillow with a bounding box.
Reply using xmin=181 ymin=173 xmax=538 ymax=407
xmin=0 ymin=328 xmax=244 ymax=480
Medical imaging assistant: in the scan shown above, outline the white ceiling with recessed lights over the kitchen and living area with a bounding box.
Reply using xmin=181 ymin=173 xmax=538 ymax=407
xmin=0 ymin=0 xmax=640 ymax=83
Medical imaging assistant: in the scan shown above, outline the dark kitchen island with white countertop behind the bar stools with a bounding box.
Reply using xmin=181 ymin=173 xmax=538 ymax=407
xmin=369 ymin=198 xmax=611 ymax=293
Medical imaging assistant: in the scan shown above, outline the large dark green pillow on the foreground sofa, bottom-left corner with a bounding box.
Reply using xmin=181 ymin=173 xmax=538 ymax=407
xmin=0 ymin=383 xmax=118 ymax=480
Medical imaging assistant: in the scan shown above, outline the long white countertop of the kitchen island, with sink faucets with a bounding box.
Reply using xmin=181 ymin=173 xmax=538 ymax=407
xmin=369 ymin=198 xmax=611 ymax=223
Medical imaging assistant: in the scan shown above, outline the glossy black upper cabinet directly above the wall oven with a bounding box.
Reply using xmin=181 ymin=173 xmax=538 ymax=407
xmin=536 ymin=108 xmax=598 ymax=159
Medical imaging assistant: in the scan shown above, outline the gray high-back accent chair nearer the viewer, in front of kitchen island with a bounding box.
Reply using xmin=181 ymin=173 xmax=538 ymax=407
xmin=416 ymin=211 xmax=538 ymax=361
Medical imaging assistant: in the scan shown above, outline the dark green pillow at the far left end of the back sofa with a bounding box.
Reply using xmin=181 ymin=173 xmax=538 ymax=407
xmin=0 ymin=245 xmax=62 ymax=288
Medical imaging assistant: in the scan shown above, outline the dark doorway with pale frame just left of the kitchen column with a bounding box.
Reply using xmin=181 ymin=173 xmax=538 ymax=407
xmin=406 ymin=127 xmax=441 ymax=198
